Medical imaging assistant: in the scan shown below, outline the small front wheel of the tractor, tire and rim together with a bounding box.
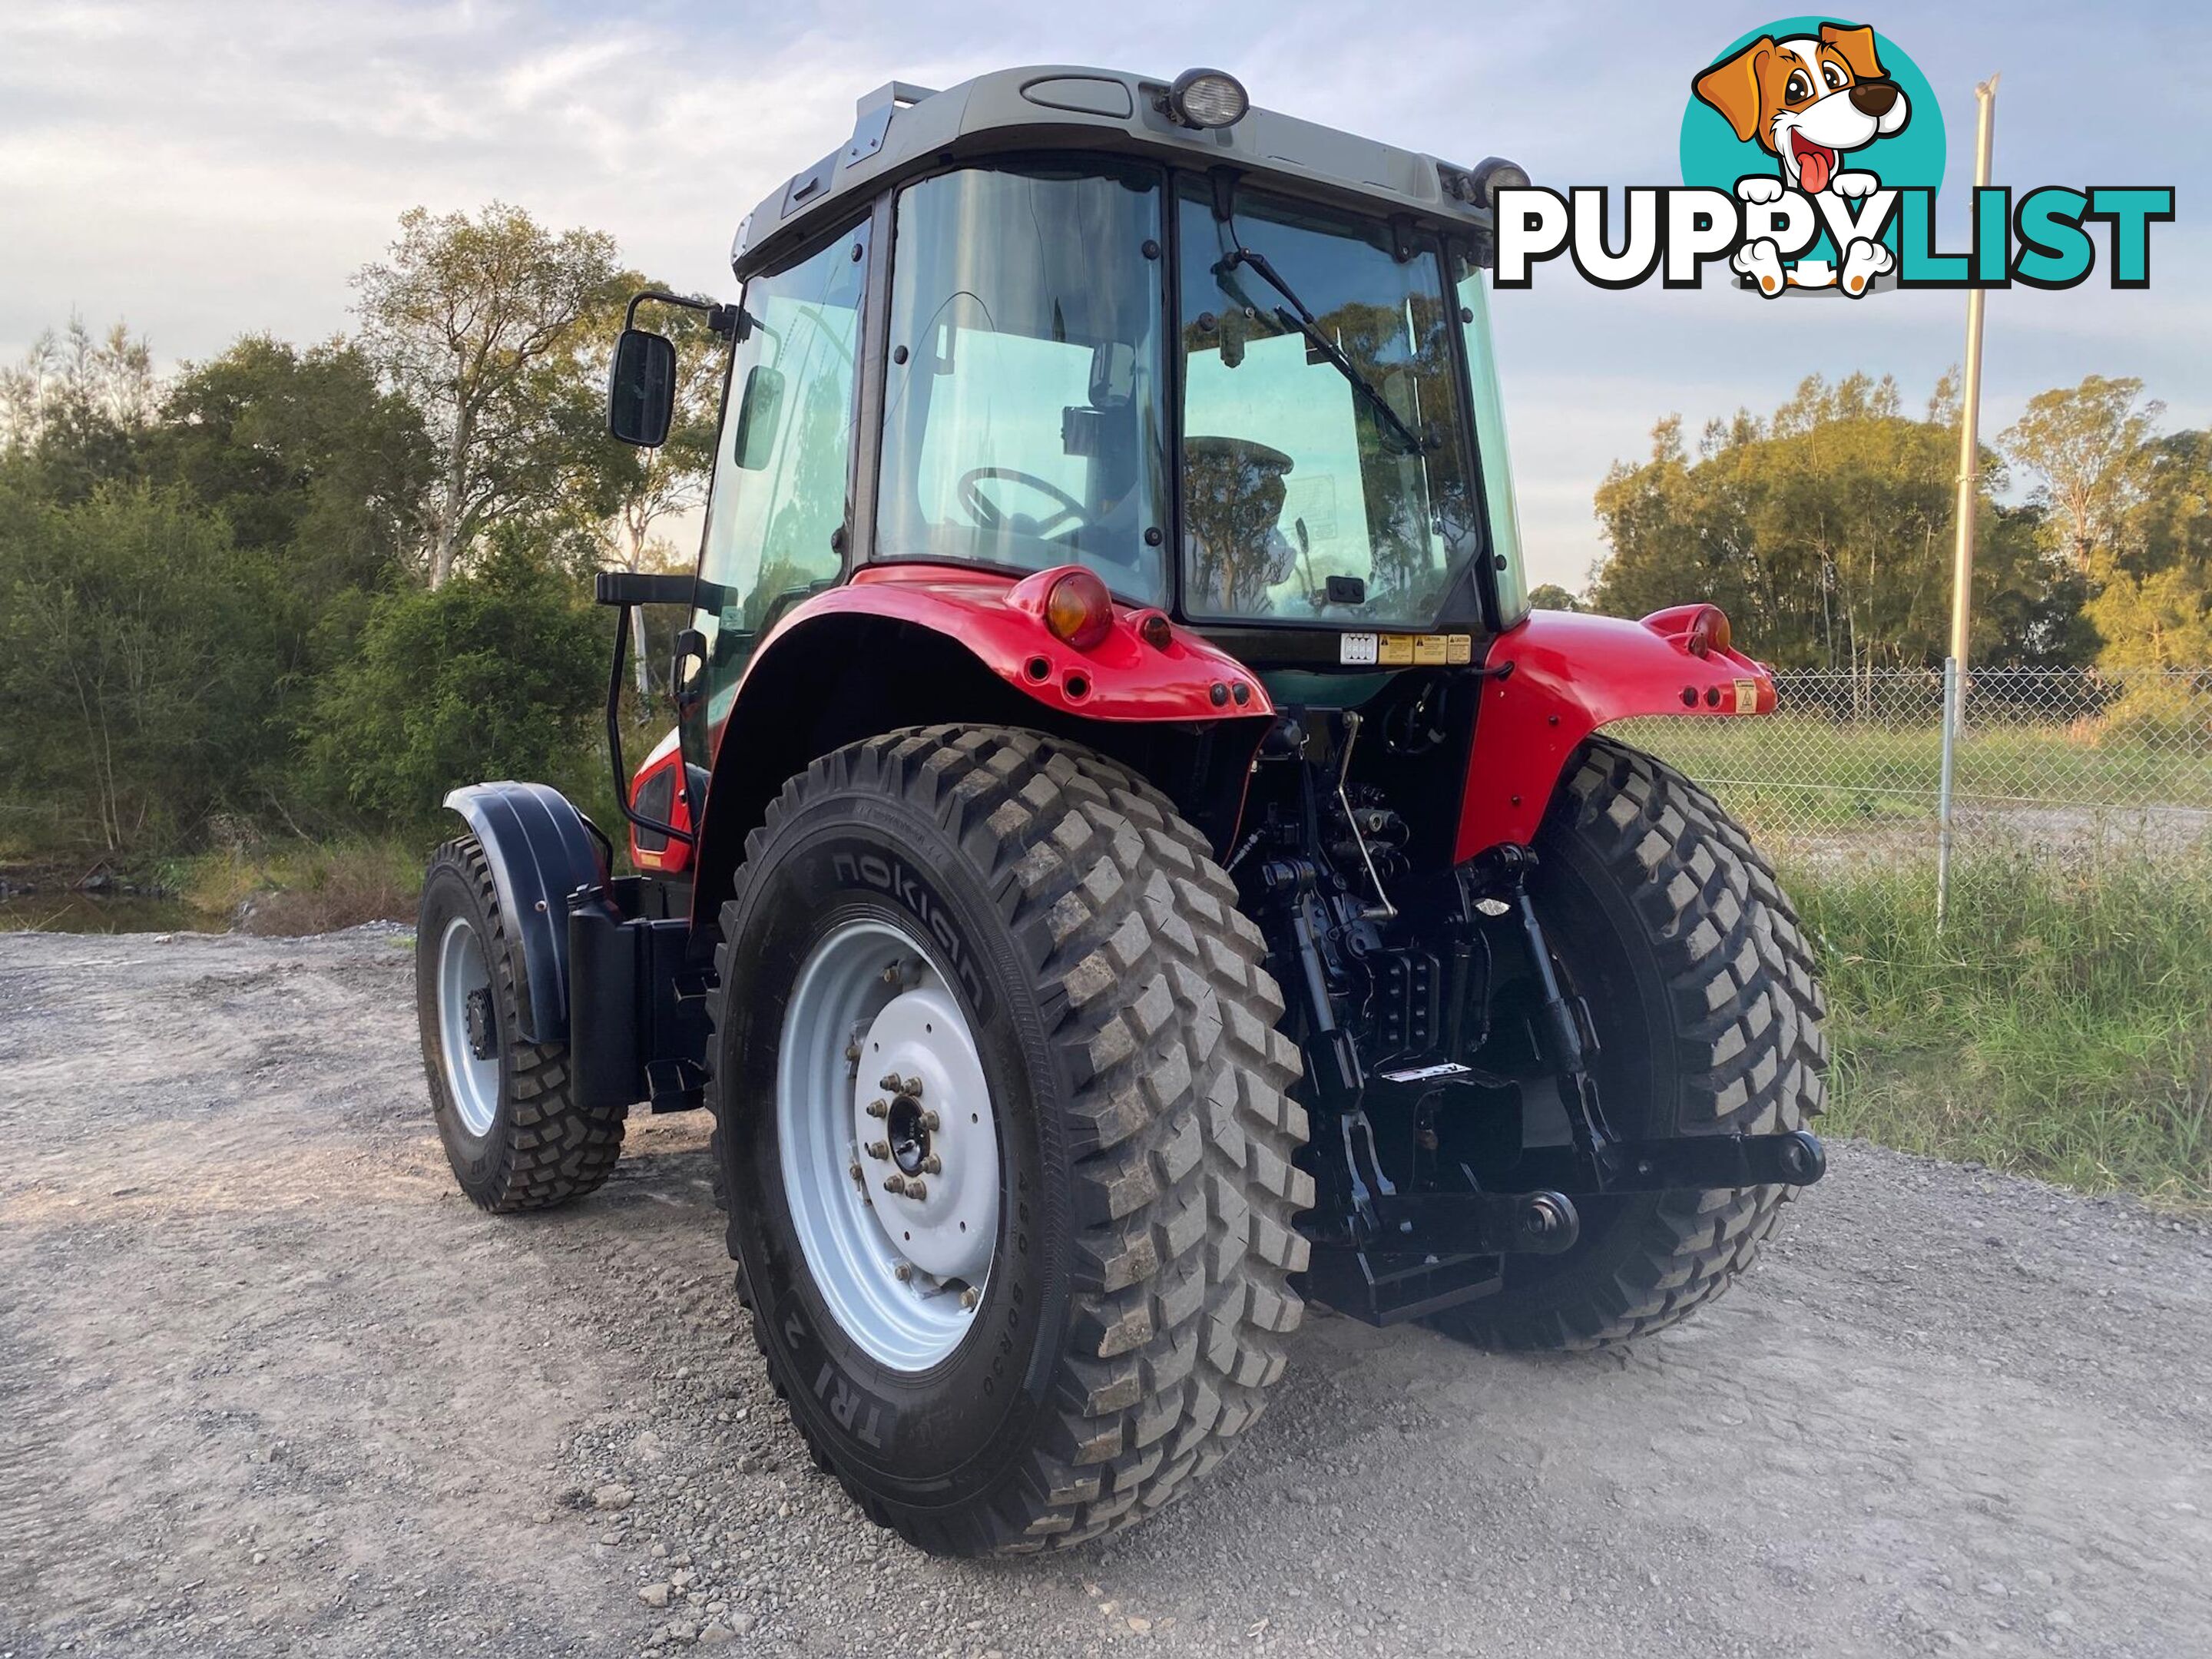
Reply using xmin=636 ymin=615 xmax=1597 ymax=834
xmin=416 ymin=836 xmax=628 ymax=1212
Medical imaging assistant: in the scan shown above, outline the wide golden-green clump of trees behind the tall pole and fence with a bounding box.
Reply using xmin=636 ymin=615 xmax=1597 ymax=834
xmin=1591 ymin=376 xmax=2079 ymax=671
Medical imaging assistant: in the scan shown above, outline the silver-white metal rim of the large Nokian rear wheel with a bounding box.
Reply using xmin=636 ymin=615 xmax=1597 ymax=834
xmin=777 ymin=920 xmax=998 ymax=1372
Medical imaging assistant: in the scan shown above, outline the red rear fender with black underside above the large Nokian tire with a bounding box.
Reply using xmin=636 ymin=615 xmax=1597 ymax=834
xmin=692 ymin=564 xmax=1274 ymax=920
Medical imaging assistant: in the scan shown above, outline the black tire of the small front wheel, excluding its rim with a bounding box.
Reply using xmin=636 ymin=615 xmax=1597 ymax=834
xmin=416 ymin=836 xmax=628 ymax=1214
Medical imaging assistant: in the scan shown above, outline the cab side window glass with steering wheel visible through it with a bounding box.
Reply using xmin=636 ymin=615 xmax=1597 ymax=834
xmin=876 ymin=166 xmax=1168 ymax=604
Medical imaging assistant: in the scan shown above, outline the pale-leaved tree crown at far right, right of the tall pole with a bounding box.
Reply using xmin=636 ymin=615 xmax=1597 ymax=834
xmin=1998 ymin=374 xmax=2166 ymax=578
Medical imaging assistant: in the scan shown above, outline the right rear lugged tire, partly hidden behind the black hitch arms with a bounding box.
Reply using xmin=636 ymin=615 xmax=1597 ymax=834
xmin=1429 ymin=737 xmax=1827 ymax=1349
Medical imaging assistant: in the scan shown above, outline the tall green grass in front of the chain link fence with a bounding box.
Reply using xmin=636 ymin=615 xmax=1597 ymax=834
xmin=1783 ymin=852 xmax=2212 ymax=1204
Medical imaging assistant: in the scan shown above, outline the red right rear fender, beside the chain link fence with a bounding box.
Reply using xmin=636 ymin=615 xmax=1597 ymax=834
xmin=1453 ymin=606 xmax=1774 ymax=860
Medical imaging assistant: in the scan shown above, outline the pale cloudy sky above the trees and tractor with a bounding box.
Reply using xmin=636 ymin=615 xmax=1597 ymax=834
xmin=0 ymin=0 xmax=2212 ymax=588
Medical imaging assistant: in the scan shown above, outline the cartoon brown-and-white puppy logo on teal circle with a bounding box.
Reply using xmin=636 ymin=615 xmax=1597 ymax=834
xmin=1684 ymin=18 xmax=1942 ymax=299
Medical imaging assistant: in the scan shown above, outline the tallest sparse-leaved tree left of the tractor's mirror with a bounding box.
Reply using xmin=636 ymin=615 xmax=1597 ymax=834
xmin=354 ymin=201 xmax=619 ymax=586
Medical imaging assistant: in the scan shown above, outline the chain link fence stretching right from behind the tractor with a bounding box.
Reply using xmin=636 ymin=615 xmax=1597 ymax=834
xmin=1611 ymin=668 xmax=2212 ymax=863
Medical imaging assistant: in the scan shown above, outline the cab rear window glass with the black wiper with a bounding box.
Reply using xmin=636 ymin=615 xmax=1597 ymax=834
xmin=1179 ymin=179 xmax=1482 ymax=628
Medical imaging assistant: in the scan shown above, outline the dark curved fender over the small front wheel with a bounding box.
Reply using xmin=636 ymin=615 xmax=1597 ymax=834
xmin=445 ymin=783 xmax=606 ymax=1044
